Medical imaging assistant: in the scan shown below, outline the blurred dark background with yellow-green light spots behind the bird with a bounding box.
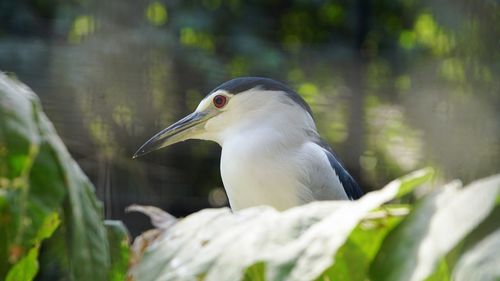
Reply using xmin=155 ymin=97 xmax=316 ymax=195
xmin=0 ymin=0 xmax=500 ymax=234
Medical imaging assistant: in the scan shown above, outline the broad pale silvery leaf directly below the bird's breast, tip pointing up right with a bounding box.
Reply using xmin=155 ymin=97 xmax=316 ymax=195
xmin=130 ymin=167 xmax=427 ymax=281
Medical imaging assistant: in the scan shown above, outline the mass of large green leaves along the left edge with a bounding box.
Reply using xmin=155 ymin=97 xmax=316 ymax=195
xmin=0 ymin=73 xmax=128 ymax=281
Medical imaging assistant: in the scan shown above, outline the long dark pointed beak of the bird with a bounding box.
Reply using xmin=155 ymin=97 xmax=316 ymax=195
xmin=132 ymin=111 xmax=210 ymax=158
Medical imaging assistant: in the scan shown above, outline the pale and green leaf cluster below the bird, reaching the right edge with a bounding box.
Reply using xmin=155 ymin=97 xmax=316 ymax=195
xmin=130 ymin=169 xmax=500 ymax=280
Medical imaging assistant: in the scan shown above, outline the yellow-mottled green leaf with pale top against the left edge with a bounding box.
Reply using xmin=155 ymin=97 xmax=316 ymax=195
xmin=0 ymin=73 xmax=42 ymax=279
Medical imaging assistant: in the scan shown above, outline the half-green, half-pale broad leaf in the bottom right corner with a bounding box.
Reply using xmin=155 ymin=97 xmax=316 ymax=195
xmin=370 ymin=176 xmax=500 ymax=280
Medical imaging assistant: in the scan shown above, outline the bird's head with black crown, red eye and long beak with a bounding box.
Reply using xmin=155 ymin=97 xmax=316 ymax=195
xmin=134 ymin=77 xmax=314 ymax=158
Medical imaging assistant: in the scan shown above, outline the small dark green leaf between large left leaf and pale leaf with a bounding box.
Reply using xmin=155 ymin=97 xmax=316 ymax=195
xmin=104 ymin=220 xmax=129 ymax=281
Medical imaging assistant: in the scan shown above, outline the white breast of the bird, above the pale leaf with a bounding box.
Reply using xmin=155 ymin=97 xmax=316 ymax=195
xmin=221 ymin=128 xmax=301 ymax=210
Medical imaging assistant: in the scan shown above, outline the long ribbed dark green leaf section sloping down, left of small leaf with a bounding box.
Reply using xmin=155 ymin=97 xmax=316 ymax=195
xmin=38 ymin=106 xmax=111 ymax=280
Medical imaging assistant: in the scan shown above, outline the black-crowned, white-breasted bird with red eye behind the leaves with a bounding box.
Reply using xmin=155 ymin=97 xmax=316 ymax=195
xmin=133 ymin=77 xmax=363 ymax=211
